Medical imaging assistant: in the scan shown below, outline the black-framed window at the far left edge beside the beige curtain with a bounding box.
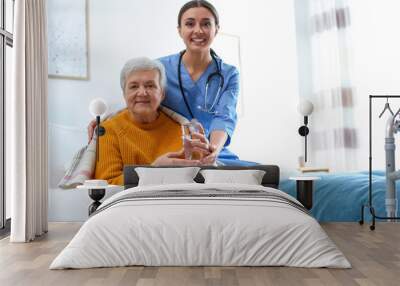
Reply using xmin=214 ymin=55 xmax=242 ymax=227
xmin=0 ymin=0 xmax=14 ymax=233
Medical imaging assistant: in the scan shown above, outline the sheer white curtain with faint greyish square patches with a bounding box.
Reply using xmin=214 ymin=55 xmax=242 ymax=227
xmin=310 ymin=0 xmax=358 ymax=171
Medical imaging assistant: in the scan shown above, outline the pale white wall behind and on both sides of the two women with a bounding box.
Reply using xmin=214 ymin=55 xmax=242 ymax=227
xmin=49 ymin=0 xmax=301 ymax=220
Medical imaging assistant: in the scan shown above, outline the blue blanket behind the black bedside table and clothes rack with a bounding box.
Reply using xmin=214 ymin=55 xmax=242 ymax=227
xmin=279 ymin=171 xmax=400 ymax=222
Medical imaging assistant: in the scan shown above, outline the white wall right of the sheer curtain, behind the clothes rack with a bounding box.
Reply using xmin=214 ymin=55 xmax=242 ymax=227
xmin=349 ymin=0 xmax=400 ymax=170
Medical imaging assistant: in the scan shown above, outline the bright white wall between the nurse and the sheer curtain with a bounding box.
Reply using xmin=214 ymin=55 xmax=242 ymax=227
xmin=219 ymin=0 xmax=301 ymax=173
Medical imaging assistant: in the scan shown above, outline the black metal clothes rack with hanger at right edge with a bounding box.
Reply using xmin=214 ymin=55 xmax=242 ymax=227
xmin=359 ymin=95 xmax=400 ymax=230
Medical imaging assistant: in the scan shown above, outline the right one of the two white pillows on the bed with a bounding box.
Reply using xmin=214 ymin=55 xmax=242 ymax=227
xmin=200 ymin=170 xmax=265 ymax=185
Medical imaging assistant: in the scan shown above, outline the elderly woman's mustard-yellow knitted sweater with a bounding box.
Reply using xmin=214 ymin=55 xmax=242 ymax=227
xmin=95 ymin=110 xmax=182 ymax=185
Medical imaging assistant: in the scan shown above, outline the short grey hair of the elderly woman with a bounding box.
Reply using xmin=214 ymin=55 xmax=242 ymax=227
xmin=120 ymin=57 xmax=167 ymax=90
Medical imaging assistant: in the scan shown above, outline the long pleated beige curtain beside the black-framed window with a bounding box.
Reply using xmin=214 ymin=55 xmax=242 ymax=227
xmin=6 ymin=0 xmax=48 ymax=242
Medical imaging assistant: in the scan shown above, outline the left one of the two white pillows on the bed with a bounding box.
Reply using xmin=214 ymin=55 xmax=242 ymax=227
xmin=135 ymin=167 xmax=200 ymax=186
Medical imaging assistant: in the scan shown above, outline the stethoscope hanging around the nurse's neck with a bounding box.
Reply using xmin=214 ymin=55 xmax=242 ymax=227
xmin=178 ymin=50 xmax=225 ymax=118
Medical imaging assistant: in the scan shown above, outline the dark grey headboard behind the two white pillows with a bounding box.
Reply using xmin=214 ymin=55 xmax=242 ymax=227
xmin=124 ymin=165 xmax=279 ymax=189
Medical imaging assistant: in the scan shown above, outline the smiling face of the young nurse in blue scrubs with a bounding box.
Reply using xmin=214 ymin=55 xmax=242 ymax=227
xmin=178 ymin=7 xmax=218 ymax=52
